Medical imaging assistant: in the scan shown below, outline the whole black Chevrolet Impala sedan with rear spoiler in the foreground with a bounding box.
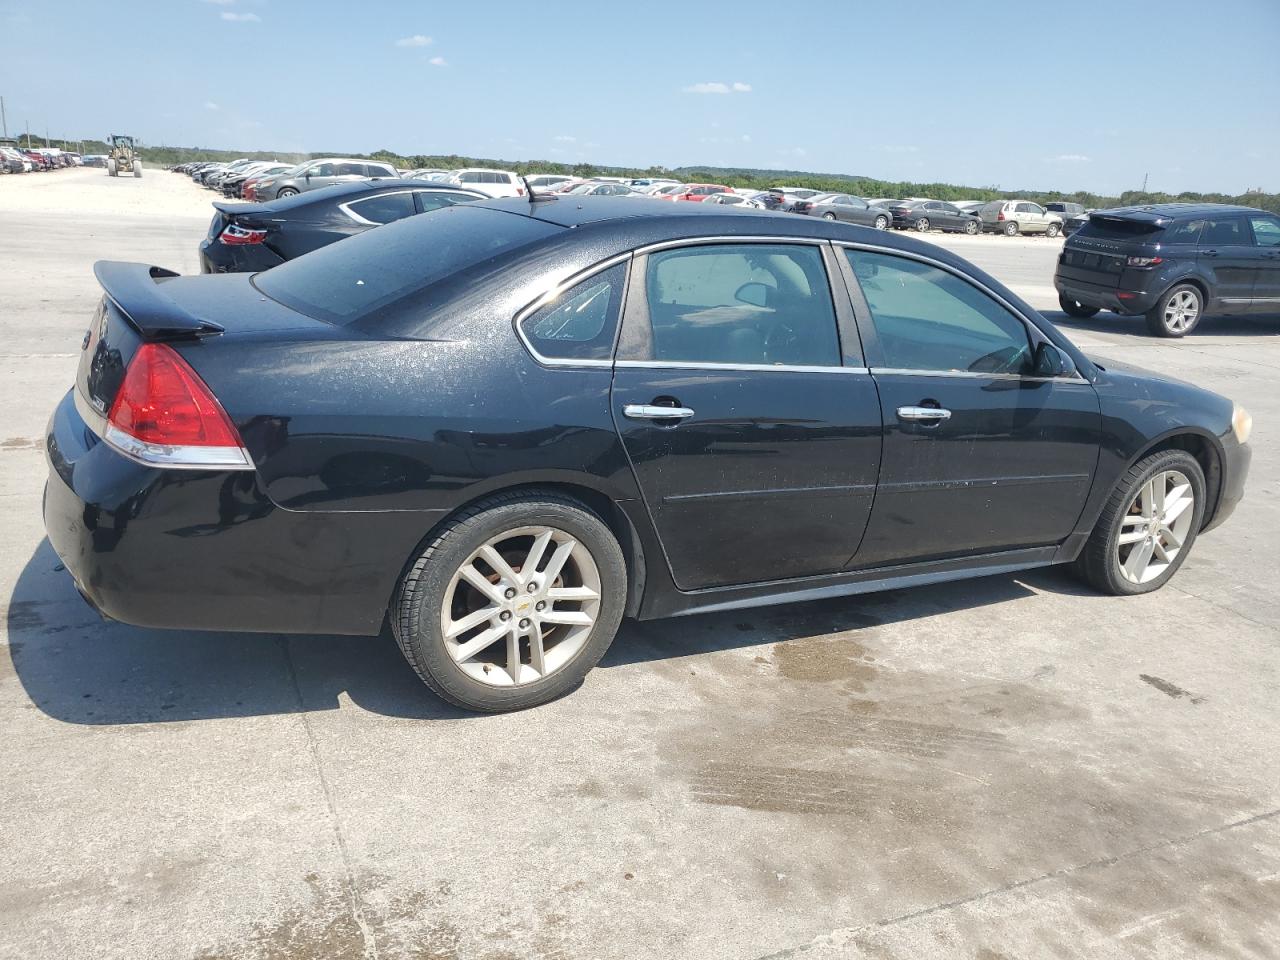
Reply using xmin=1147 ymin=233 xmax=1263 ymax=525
xmin=45 ymin=197 xmax=1251 ymax=710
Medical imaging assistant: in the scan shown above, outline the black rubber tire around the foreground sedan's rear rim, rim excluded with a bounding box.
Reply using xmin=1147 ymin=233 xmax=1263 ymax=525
xmin=389 ymin=490 xmax=627 ymax=713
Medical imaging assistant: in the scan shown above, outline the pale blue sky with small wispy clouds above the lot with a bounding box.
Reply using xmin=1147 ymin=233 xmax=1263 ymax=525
xmin=0 ymin=0 xmax=1280 ymax=192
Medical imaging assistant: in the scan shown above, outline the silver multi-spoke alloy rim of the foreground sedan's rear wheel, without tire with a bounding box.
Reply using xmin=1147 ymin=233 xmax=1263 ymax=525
xmin=440 ymin=526 xmax=600 ymax=686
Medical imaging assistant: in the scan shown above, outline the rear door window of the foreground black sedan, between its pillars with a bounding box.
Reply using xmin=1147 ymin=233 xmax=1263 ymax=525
xmin=634 ymin=243 xmax=841 ymax=366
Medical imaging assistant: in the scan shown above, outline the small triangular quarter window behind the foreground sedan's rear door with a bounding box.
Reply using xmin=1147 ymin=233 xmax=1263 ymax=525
xmin=520 ymin=264 xmax=626 ymax=360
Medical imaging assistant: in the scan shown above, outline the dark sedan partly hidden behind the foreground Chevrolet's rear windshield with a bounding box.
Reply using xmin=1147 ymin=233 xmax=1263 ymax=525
xmin=200 ymin=180 xmax=489 ymax=274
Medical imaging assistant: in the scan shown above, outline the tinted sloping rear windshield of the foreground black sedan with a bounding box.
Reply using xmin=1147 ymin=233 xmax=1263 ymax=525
xmin=253 ymin=206 xmax=562 ymax=325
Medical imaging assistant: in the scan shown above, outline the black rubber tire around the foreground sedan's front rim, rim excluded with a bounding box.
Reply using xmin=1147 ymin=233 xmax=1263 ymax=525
xmin=1074 ymin=451 xmax=1204 ymax=596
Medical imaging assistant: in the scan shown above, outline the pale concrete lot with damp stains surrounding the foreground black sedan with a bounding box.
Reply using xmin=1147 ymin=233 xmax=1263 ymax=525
xmin=0 ymin=169 xmax=1280 ymax=960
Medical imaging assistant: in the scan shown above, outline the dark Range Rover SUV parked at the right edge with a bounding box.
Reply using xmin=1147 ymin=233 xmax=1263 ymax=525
xmin=1053 ymin=204 xmax=1280 ymax=337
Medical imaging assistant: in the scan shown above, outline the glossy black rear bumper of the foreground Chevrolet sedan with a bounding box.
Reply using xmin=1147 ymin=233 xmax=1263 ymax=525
xmin=45 ymin=393 xmax=426 ymax=635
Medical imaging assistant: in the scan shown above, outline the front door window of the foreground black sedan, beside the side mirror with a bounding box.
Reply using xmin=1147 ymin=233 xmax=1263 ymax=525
xmin=845 ymin=250 xmax=1032 ymax=374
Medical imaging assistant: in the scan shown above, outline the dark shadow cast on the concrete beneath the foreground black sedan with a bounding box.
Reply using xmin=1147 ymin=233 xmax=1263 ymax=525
xmin=0 ymin=540 xmax=1087 ymax=726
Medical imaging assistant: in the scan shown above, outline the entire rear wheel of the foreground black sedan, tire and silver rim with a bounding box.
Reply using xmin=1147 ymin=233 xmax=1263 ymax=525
xmin=390 ymin=492 xmax=627 ymax=713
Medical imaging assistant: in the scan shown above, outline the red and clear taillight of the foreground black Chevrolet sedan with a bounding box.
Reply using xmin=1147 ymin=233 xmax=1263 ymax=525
xmin=104 ymin=343 xmax=252 ymax=470
